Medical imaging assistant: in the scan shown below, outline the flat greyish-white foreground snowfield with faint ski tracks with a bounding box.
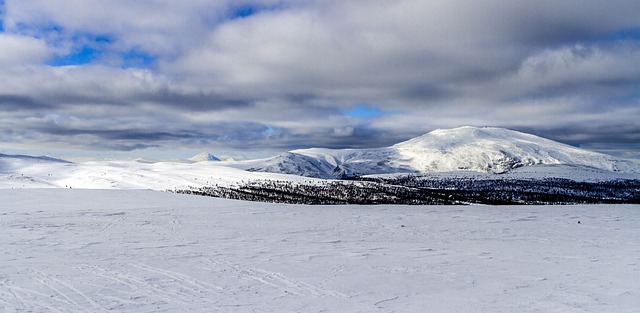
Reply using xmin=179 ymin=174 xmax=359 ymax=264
xmin=0 ymin=189 xmax=640 ymax=312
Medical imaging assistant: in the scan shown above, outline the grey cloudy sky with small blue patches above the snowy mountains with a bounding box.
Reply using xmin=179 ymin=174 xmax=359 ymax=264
xmin=0 ymin=0 xmax=640 ymax=159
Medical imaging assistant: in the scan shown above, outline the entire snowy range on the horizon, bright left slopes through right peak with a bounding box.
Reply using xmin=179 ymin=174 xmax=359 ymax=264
xmin=0 ymin=127 xmax=640 ymax=190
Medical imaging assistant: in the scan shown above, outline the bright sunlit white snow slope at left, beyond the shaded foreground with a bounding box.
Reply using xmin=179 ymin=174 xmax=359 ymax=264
xmin=0 ymin=156 xmax=315 ymax=190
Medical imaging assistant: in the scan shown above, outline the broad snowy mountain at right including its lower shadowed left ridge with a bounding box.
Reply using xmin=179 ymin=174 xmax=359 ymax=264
xmin=247 ymin=126 xmax=640 ymax=178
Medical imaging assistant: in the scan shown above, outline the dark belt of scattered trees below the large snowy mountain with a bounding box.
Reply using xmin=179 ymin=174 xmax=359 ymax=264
xmin=174 ymin=175 xmax=640 ymax=205
